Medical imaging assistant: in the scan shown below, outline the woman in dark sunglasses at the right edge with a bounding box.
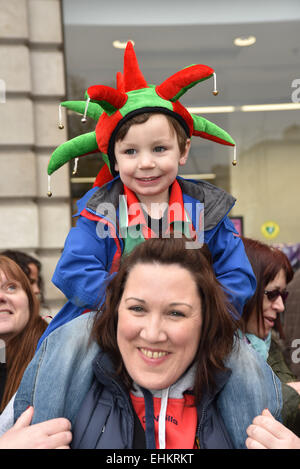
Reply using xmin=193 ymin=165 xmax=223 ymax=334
xmin=243 ymin=238 xmax=300 ymax=436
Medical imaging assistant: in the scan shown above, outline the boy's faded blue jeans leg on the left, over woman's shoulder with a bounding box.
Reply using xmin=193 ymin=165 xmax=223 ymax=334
xmin=14 ymin=313 xmax=99 ymax=424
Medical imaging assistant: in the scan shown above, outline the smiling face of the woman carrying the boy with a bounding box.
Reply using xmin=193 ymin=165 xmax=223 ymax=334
xmin=117 ymin=264 xmax=202 ymax=389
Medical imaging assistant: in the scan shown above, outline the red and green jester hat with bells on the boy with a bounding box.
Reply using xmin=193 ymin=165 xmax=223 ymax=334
xmin=48 ymin=41 xmax=236 ymax=195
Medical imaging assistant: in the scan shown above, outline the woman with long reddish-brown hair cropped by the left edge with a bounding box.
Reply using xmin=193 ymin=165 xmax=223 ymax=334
xmin=0 ymin=255 xmax=48 ymax=412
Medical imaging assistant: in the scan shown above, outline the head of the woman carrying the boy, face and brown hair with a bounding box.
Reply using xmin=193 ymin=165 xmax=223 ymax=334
xmin=94 ymin=238 xmax=237 ymax=403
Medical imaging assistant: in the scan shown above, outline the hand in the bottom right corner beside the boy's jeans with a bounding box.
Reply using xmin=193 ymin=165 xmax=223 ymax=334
xmin=246 ymin=409 xmax=300 ymax=449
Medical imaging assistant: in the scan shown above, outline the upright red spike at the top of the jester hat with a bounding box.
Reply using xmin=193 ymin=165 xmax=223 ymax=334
xmin=124 ymin=41 xmax=148 ymax=92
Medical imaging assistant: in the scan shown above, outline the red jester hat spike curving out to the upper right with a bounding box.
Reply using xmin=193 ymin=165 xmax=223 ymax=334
xmin=155 ymin=65 xmax=214 ymax=102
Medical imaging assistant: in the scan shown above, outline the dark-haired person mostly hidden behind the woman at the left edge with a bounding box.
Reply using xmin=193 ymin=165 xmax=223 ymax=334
xmin=1 ymin=249 xmax=44 ymax=303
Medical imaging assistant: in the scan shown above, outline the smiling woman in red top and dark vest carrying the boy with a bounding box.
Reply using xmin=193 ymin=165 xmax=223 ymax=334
xmin=74 ymin=238 xmax=237 ymax=448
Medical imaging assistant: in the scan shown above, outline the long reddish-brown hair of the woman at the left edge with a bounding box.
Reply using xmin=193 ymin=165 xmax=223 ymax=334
xmin=0 ymin=255 xmax=48 ymax=412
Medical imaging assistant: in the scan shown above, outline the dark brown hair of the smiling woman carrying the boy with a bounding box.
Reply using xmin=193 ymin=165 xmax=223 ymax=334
xmin=92 ymin=237 xmax=238 ymax=403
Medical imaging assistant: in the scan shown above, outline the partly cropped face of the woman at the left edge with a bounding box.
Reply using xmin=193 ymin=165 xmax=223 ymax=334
xmin=0 ymin=270 xmax=29 ymax=341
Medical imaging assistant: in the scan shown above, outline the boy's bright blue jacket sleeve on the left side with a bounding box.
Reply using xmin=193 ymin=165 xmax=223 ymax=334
xmin=52 ymin=217 xmax=117 ymax=309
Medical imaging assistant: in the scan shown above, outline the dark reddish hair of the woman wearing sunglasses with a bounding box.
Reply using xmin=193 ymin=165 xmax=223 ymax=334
xmin=242 ymin=238 xmax=294 ymax=338
